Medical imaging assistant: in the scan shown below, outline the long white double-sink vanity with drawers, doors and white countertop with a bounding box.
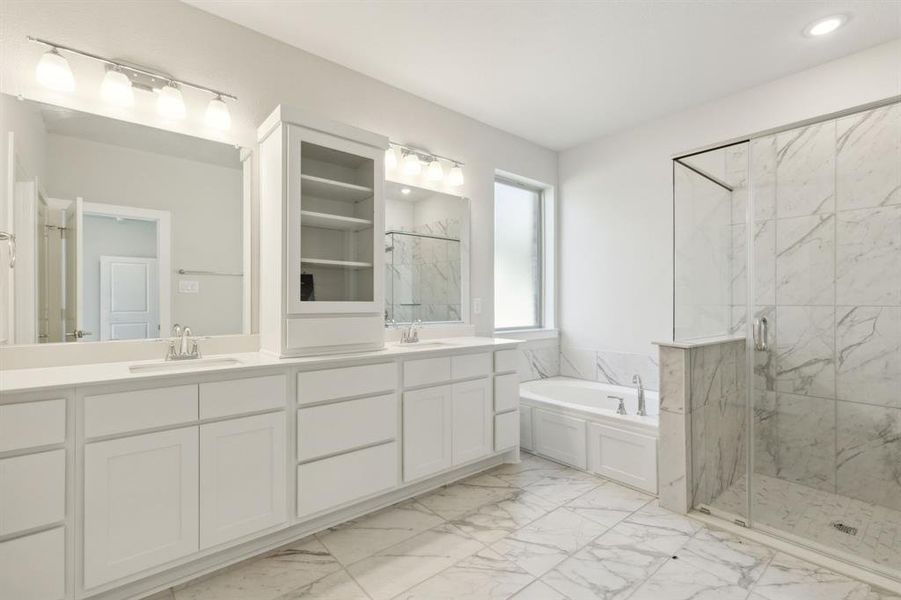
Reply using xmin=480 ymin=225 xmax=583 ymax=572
xmin=0 ymin=338 xmax=519 ymax=600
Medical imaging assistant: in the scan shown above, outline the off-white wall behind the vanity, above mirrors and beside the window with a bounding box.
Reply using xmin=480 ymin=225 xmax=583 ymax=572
xmin=0 ymin=0 xmax=557 ymax=333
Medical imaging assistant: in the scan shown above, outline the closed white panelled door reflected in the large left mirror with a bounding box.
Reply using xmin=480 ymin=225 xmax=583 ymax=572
xmin=100 ymin=256 xmax=160 ymax=340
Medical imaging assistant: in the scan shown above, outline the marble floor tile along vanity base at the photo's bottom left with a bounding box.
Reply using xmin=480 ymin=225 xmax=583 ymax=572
xmin=174 ymin=538 xmax=341 ymax=600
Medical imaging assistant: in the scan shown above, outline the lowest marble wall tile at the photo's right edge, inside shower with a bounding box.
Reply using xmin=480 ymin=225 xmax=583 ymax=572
xmin=836 ymin=402 xmax=901 ymax=510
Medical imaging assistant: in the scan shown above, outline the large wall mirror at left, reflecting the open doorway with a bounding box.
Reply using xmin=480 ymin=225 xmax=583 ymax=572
xmin=0 ymin=95 xmax=250 ymax=344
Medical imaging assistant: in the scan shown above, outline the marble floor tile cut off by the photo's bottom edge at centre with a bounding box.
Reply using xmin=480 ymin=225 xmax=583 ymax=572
xmin=396 ymin=549 xmax=535 ymax=600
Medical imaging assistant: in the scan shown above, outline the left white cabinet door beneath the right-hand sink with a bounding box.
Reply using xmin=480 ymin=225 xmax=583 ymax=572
xmin=404 ymin=385 xmax=453 ymax=481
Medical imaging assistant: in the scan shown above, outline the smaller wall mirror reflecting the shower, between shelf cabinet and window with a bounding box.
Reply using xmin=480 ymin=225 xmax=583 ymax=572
xmin=385 ymin=181 xmax=469 ymax=323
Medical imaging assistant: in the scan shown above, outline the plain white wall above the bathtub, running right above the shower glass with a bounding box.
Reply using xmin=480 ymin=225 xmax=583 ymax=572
xmin=559 ymin=40 xmax=901 ymax=370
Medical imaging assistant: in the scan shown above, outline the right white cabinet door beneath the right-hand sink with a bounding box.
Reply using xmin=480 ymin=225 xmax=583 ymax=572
xmin=453 ymin=378 xmax=494 ymax=465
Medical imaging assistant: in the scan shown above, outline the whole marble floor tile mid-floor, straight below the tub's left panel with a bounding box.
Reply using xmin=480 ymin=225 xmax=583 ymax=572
xmin=491 ymin=508 xmax=606 ymax=576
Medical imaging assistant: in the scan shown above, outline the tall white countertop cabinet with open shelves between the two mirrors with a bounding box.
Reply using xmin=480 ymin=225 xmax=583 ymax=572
xmin=258 ymin=106 xmax=388 ymax=356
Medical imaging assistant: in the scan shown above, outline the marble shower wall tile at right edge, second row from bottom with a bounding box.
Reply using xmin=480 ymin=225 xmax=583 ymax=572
xmin=835 ymin=306 xmax=901 ymax=408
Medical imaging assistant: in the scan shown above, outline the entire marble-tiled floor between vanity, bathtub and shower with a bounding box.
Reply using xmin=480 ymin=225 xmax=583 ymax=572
xmin=153 ymin=454 xmax=901 ymax=600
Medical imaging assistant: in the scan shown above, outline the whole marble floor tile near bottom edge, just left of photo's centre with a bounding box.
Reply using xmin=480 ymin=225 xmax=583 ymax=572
xmin=347 ymin=524 xmax=484 ymax=600
